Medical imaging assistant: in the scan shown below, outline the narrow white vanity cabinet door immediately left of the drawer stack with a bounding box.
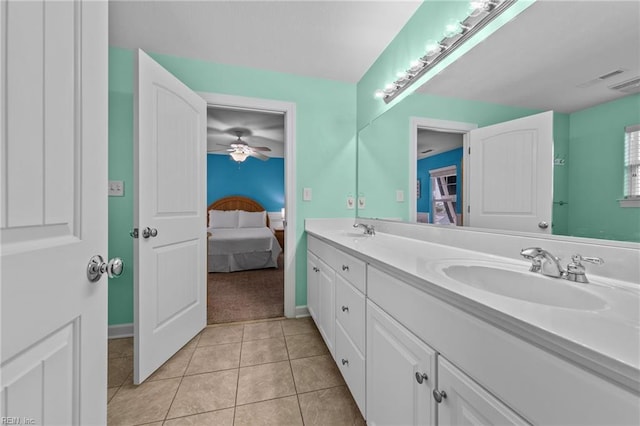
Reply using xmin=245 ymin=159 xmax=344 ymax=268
xmin=317 ymin=259 xmax=336 ymax=357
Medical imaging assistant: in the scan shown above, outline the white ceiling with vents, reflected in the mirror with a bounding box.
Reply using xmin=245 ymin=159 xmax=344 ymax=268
xmin=418 ymin=0 xmax=640 ymax=113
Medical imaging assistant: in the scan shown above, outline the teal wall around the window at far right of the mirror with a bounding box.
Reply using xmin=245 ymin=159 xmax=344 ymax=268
xmin=566 ymin=94 xmax=640 ymax=242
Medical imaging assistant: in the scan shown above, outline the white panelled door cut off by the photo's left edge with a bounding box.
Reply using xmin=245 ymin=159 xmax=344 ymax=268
xmin=0 ymin=0 xmax=108 ymax=425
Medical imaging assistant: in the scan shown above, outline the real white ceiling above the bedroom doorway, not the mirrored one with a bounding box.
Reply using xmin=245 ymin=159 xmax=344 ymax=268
xmin=109 ymin=0 xmax=421 ymax=83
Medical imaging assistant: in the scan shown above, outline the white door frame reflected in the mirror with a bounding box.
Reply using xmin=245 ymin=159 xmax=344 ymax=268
xmin=408 ymin=117 xmax=478 ymax=225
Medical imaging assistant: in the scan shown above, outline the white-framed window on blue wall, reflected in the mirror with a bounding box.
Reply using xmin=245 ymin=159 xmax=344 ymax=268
xmin=429 ymin=166 xmax=458 ymax=225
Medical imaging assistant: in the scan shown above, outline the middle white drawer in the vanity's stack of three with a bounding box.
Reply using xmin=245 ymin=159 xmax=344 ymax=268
xmin=336 ymin=276 xmax=366 ymax=353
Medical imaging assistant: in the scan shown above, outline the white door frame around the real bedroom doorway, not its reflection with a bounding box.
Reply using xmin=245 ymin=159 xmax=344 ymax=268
xmin=196 ymin=92 xmax=297 ymax=318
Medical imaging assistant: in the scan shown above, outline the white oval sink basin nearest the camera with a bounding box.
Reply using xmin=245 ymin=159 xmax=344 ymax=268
xmin=438 ymin=261 xmax=607 ymax=310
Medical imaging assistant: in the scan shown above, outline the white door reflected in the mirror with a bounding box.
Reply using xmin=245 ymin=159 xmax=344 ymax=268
xmin=467 ymin=111 xmax=553 ymax=234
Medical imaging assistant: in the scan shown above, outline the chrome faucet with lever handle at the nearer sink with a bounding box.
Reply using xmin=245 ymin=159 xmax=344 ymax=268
xmin=520 ymin=247 xmax=604 ymax=283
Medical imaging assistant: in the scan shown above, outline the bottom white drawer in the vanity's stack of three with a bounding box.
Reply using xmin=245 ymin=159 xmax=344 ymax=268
xmin=336 ymin=324 xmax=366 ymax=416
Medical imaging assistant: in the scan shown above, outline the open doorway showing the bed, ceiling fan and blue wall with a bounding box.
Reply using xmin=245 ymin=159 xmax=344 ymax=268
xmin=200 ymin=93 xmax=295 ymax=324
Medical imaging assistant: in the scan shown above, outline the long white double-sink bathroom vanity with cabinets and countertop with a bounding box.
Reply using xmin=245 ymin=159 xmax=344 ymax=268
xmin=306 ymin=219 xmax=640 ymax=425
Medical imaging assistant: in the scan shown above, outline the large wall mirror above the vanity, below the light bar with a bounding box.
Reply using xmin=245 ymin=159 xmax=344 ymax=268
xmin=357 ymin=1 xmax=640 ymax=242
